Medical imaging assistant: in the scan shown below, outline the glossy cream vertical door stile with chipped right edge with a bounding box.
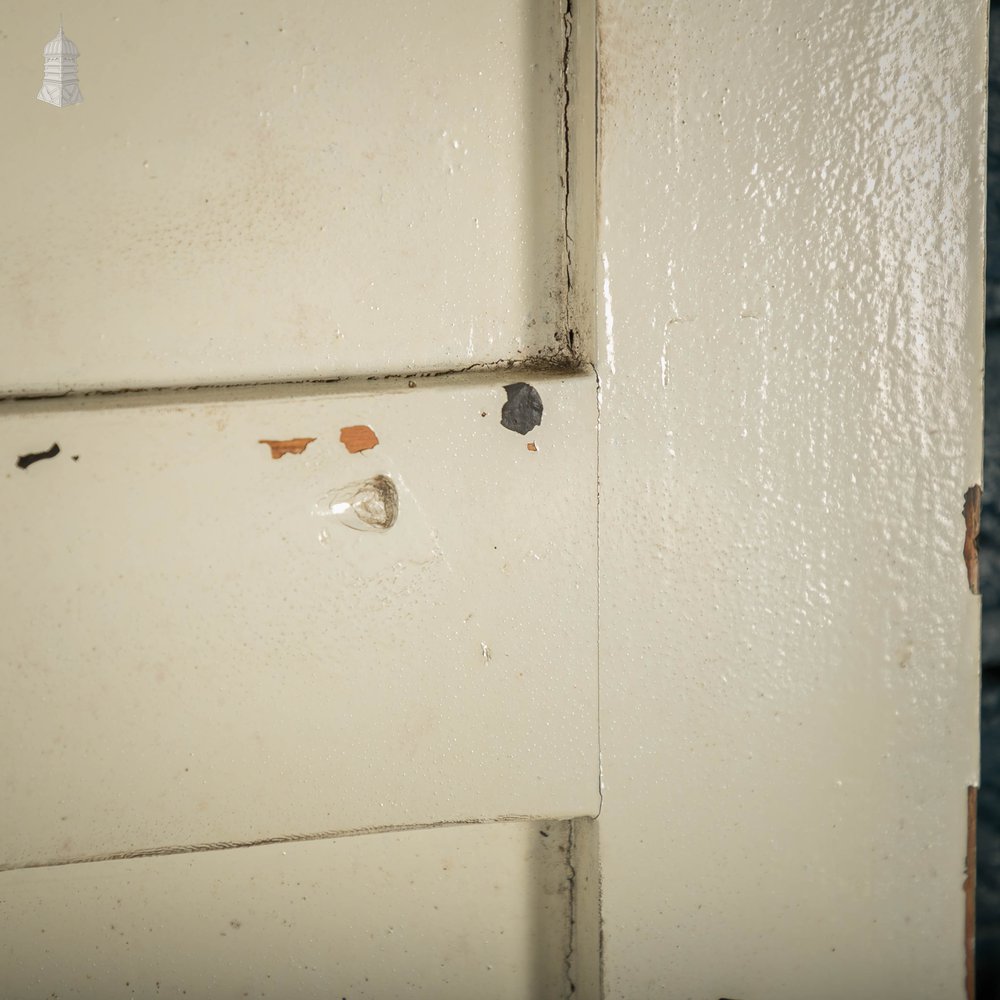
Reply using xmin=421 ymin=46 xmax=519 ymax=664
xmin=598 ymin=0 xmax=986 ymax=1000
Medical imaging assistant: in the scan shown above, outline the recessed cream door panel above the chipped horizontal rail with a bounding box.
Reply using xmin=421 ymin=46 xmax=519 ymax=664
xmin=0 ymin=0 xmax=566 ymax=393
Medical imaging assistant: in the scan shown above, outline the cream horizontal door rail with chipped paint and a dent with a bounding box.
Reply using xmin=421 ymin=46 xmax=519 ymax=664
xmin=0 ymin=376 xmax=598 ymax=865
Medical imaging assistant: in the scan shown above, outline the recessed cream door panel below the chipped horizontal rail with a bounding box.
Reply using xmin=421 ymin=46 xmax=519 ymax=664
xmin=0 ymin=823 xmax=570 ymax=1000
